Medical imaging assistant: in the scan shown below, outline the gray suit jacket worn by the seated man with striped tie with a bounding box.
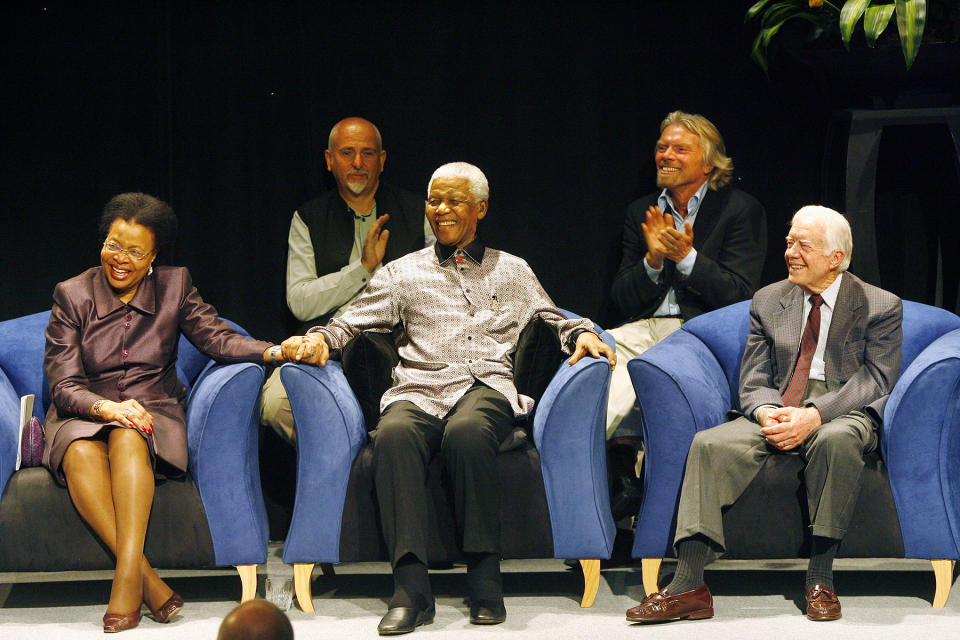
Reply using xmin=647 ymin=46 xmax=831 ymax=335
xmin=740 ymin=273 xmax=903 ymax=424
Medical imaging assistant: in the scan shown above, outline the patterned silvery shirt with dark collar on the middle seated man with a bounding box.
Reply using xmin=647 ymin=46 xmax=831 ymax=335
xmin=311 ymin=240 xmax=593 ymax=418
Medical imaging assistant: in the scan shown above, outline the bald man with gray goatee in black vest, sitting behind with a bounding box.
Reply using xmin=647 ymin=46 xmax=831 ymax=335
xmin=260 ymin=117 xmax=434 ymax=442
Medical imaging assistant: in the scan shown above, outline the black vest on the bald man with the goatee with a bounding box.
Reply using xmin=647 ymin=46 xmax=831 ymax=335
xmin=297 ymin=182 xmax=425 ymax=327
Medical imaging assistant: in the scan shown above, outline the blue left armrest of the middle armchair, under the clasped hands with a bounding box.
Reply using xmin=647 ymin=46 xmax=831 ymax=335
xmin=280 ymin=361 xmax=367 ymax=564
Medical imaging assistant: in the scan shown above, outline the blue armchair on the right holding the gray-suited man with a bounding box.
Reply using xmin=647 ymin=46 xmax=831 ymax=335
xmin=627 ymin=301 xmax=960 ymax=607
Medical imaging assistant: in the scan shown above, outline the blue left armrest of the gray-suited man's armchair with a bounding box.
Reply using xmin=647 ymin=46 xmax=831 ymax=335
xmin=627 ymin=329 xmax=733 ymax=558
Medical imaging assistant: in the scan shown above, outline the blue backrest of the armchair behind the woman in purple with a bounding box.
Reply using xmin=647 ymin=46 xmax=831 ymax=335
xmin=0 ymin=311 xmax=248 ymax=420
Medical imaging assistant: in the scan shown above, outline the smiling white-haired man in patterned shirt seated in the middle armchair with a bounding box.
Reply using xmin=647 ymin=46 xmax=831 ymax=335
xmin=288 ymin=162 xmax=616 ymax=635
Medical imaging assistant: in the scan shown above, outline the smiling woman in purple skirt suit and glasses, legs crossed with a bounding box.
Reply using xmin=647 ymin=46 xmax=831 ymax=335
xmin=43 ymin=193 xmax=309 ymax=632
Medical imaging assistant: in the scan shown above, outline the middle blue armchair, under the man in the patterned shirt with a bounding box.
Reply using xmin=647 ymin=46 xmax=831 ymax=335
xmin=280 ymin=314 xmax=615 ymax=611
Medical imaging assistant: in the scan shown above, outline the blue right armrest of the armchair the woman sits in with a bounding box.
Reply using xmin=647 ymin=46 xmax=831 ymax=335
xmin=187 ymin=363 xmax=269 ymax=566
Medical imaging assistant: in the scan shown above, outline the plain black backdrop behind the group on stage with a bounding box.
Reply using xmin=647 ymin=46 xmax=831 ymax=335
xmin=0 ymin=0 xmax=956 ymax=340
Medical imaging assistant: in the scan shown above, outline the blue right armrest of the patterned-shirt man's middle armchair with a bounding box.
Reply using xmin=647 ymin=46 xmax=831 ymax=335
xmin=533 ymin=342 xmax=616 ymax=558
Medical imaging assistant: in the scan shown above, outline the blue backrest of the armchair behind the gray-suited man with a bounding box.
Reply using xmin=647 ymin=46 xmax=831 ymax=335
xmin=682 ymin=300 xmax=960 ymax=398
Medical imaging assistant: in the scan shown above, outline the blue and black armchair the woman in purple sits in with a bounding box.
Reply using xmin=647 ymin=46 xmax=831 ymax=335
xmin=0 ymin=312 xmax=267 ymax=600
